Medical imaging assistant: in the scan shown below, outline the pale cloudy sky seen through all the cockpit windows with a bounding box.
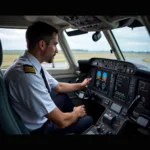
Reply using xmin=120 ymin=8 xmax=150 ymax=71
xmin=0 ymin=27 xmax=150 ymax=52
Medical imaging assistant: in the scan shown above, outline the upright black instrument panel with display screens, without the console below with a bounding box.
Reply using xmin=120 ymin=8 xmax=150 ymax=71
xmin=79 ymin=58 xmax=150 ymax=113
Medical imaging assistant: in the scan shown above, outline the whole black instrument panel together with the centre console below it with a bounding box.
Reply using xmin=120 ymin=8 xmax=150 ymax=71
xmin=79 ymin=58 xmax=150 ymax=135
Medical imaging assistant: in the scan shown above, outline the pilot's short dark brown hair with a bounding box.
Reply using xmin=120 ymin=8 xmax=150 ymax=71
xmin=26 ymin=21 xmax=58 ymax=49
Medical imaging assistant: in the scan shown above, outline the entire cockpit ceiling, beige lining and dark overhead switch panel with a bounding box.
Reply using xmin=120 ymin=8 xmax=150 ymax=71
xmin=0 ymin=16 xmax=150 ymax=31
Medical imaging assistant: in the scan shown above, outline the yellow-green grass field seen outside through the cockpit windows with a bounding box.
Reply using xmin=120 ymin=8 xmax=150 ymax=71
xmin=2 ymin=51 xmax=150 ymax=68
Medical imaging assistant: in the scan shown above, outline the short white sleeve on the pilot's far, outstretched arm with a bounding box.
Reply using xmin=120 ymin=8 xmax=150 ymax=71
xmin=44 ymin=70 xmax=58 ymax=88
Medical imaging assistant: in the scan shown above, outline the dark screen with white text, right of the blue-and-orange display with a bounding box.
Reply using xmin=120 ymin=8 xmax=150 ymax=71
xmin=113 ymin=74 xmax=130 ymax=102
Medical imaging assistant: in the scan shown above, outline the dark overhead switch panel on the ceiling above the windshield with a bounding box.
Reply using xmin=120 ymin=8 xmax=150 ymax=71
xmin=58 ymin=16 xmax=148 ymax=31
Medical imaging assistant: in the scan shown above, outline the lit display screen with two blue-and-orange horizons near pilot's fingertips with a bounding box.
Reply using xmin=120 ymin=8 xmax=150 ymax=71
xmin=95 ymin=70 xmax=110 ymax=94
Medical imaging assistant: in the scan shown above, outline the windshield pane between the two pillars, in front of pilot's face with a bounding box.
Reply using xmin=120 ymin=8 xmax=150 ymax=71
xmin=64 ymin=29 xmax=116 ymax=65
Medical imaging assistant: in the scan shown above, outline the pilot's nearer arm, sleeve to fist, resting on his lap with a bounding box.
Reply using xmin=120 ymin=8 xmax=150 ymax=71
xmin=9 ymin=68 xmax=86 ymax=128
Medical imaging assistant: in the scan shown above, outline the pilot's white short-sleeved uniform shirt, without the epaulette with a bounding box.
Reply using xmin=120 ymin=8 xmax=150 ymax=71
xmin=4 ymin=51 xmax=58 ymax=131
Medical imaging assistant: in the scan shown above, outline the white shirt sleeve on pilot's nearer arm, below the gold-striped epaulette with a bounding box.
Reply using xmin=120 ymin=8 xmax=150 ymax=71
xmin=10 ymin=72 xmax=56 ymax=117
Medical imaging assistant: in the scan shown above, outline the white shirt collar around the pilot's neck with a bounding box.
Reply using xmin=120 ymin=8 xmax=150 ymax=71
xmin=23 ymin=50 xmax=41 ymax=72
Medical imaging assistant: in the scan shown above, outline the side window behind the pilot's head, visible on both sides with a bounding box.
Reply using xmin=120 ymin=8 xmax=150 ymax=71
xmin=0 ymin=28 xmax=69 ymax=69
